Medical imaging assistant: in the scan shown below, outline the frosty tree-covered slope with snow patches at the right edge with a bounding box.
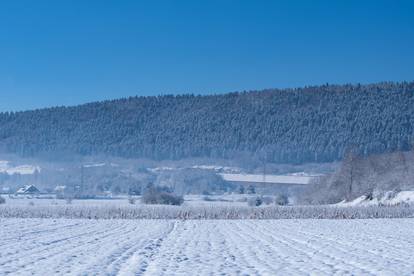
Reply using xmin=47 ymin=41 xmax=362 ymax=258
xmin=300 ymin=151 xmax=414 ymax=205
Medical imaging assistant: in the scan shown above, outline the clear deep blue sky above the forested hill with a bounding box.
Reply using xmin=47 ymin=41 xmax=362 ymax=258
xmin=0 ymin=0 xmax=414 ymax=111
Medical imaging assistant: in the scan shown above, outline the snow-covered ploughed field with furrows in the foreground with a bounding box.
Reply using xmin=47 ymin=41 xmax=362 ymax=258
xmin=0 ymin=219 xmax=414 ymax=275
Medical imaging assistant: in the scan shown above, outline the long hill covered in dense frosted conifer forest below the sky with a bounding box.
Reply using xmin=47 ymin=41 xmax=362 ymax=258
xmin=0 ymin=82 xmax=414 ymax=163
